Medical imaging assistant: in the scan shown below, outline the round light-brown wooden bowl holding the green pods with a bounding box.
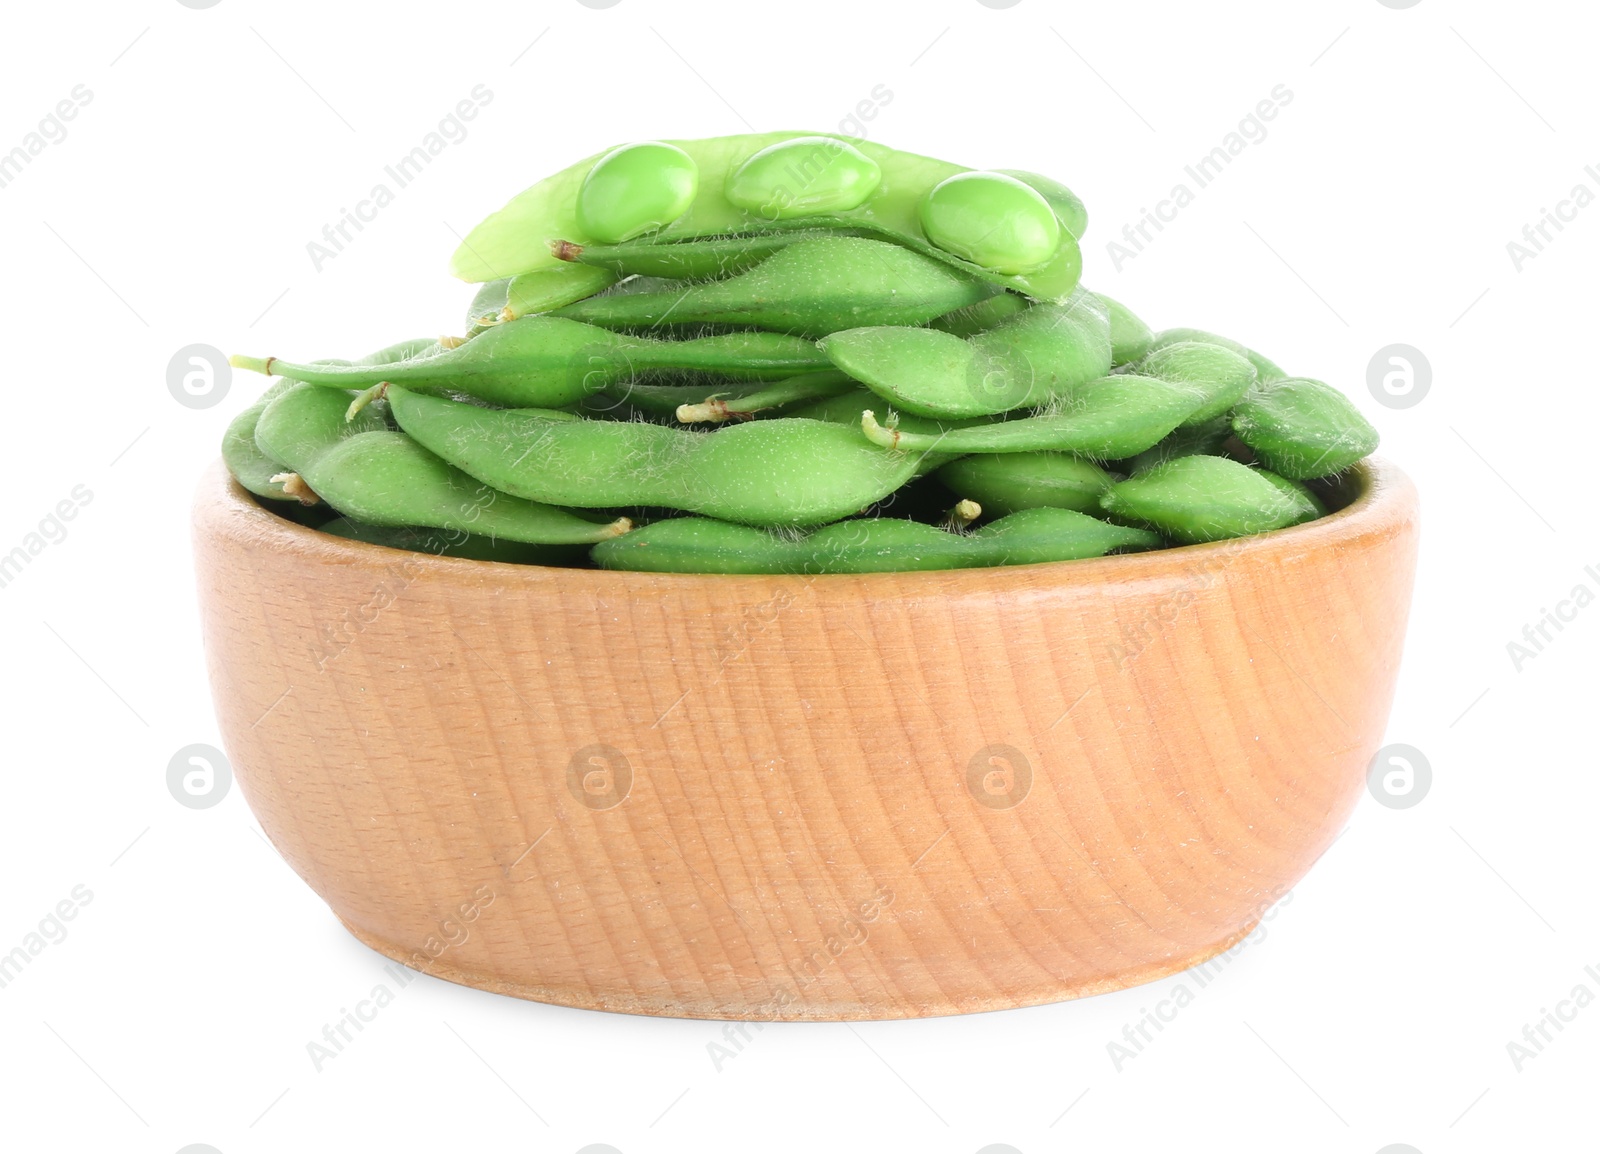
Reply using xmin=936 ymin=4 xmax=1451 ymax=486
xmin=195 ymin=464 xmax=1418 ymax=1021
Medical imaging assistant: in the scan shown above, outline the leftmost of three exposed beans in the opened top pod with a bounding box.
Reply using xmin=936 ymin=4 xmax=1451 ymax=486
xmin=576 ymin=141 xmax=699 ymax=244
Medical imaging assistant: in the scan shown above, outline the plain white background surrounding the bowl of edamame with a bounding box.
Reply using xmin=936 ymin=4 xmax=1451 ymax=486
xmin=0 ymin=0 xmax=1600 ymax=1154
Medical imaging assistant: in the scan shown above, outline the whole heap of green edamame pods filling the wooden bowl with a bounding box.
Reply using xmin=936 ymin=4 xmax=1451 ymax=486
xmin=224 ymin=133 xmax=1378 ymax=573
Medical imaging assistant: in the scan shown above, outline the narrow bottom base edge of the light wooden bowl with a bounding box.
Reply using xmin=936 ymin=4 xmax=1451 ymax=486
xmin=339 ymin=917 xmax=1259 ymax=1021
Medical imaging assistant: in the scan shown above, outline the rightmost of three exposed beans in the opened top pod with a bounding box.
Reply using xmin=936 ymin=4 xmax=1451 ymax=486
xmin=922 ymin=173 xmax=1061 ymax=275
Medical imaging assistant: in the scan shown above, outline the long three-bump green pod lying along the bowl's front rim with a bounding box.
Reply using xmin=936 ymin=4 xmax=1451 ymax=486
xmin=590 ymin=509 xmax=1160 ymax=573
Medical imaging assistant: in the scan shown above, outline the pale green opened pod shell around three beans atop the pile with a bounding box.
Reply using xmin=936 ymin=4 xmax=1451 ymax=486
xmin=451 ymin=131 xmax=1083 ymax=301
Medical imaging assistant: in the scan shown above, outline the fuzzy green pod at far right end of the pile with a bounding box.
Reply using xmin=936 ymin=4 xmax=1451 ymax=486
xmin=1234 ymin=376 xmax=1378 ymax=480
